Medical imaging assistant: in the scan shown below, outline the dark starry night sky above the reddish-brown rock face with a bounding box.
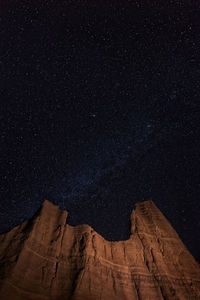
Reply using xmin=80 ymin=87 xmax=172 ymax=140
xmin=0 ymin=0 xmax=200 ymax=261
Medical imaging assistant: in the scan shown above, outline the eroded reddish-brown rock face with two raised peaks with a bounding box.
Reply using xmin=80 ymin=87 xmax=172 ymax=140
xmin=0 ymin=200 xmax=200 ymax=300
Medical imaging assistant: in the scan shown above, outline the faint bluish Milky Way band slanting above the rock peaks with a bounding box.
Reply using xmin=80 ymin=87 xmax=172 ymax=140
xmin=47 ymin=115 xmax=153 ymax=205
